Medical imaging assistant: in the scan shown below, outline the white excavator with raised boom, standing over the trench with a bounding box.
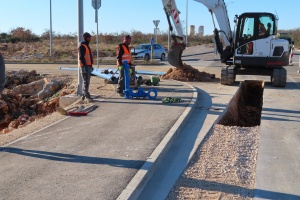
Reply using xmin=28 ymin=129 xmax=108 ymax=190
xmin=162 ymin=0 xmax=293 ymax=87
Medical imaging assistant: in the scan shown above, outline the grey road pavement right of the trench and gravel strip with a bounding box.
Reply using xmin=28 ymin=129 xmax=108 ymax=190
xmin=255 ymin=51 xmax=300 ymax=199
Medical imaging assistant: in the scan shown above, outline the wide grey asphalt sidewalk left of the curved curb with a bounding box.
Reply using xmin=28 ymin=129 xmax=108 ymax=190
xmin=0 ymin=81 xmax=192 ymax=200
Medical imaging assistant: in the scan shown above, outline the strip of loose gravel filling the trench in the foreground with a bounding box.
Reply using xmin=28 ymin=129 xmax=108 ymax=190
xmin=167 ymin=124 xmax=259 ymax=199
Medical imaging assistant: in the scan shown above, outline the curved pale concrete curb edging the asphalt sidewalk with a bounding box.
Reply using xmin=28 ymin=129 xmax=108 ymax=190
xmin=117 ymin=82 xmax=198 ymax=200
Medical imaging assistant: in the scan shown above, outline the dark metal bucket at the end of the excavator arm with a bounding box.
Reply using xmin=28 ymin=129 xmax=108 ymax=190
xmin=168 ymin=43 xmax=185 ymax=68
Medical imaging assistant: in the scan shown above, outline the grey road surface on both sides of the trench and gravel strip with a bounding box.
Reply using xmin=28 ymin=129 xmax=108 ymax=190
xmin=139 ymin=50 xmax=300 ymax=200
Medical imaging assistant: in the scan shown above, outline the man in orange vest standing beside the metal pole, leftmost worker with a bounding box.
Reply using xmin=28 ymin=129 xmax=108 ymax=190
xmin=78 ymin=32 xmax=94 ymax=101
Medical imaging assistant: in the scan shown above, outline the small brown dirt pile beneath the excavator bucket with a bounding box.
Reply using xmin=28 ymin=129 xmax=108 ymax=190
xmin=162 ymin=64 xmax=217 ymax=82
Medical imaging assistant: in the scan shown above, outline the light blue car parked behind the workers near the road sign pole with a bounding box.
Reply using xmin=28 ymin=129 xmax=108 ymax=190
xmin=131 ymin=43 xmax=166 ymax=61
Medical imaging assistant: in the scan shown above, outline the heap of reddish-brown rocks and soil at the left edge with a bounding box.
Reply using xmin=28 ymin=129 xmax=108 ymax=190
xmin=0 ymin=70 xmax=74 ymax=133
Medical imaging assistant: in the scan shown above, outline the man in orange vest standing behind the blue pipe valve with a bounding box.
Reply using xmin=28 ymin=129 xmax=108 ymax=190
xmin=117 ymin=35 xmax=135 ymax=96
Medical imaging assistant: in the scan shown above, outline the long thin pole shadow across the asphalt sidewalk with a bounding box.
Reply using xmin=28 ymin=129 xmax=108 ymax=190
xmin=0 ymin=147 xmax=145 ymax=169
